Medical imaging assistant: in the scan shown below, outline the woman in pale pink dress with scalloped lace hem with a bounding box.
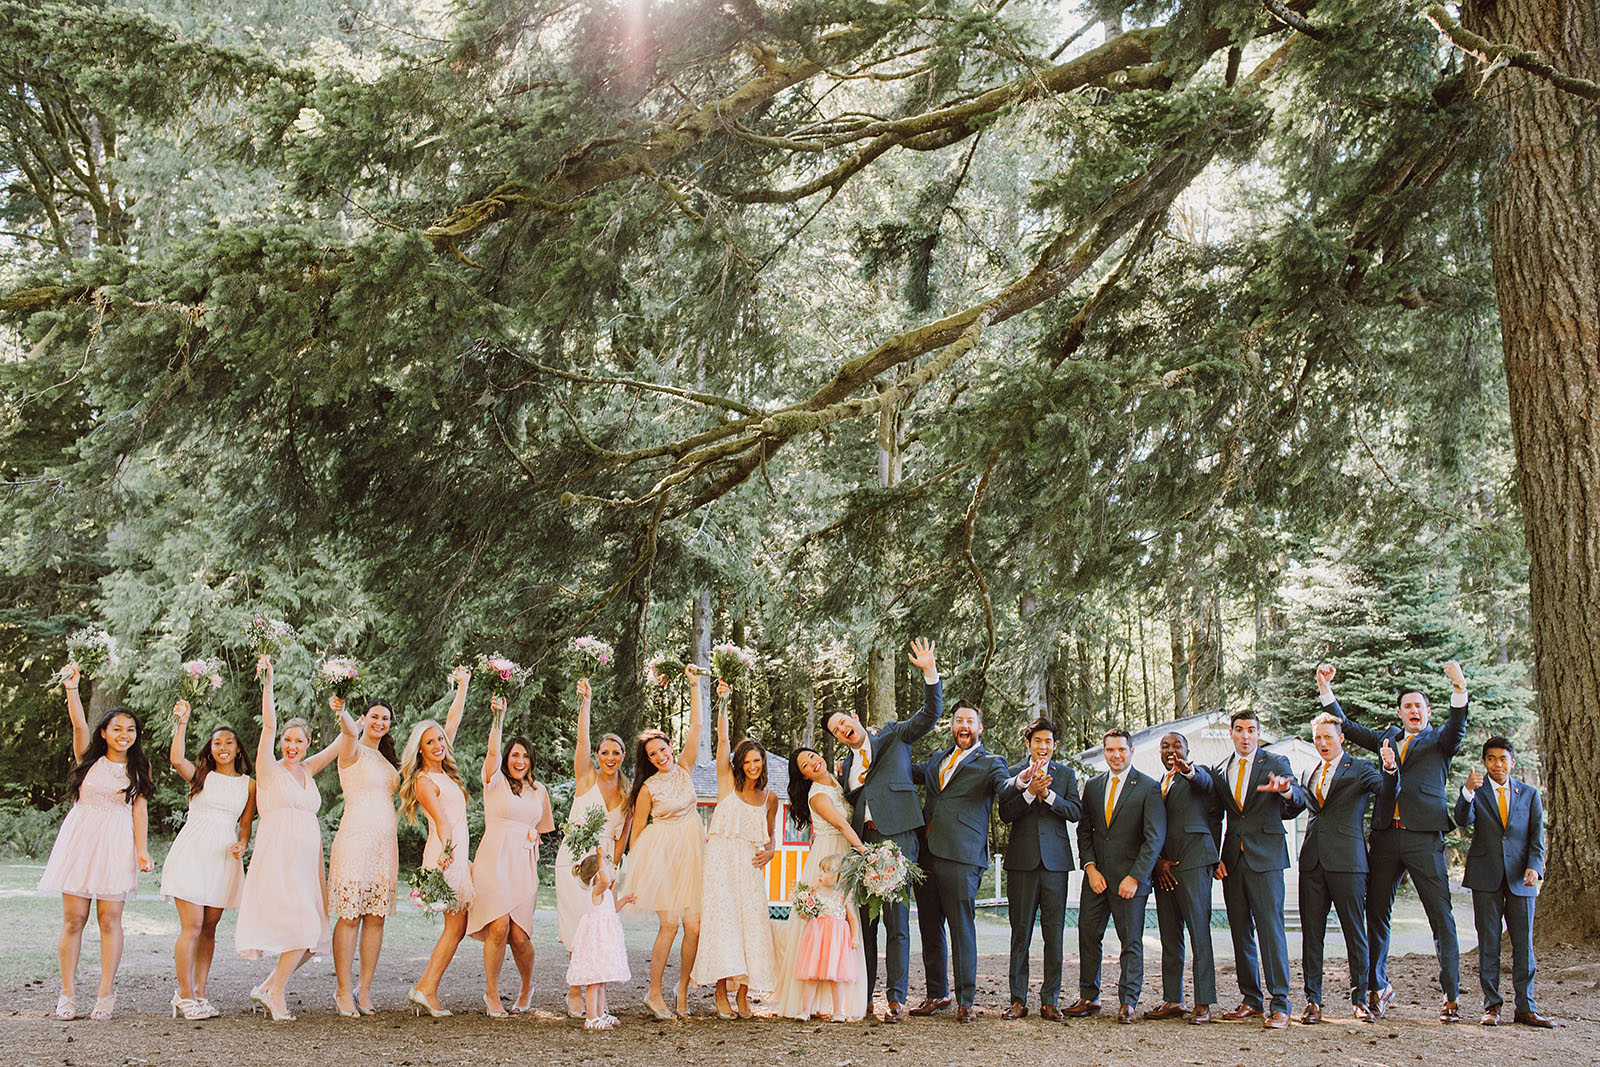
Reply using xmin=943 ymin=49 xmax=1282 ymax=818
xmin=328 ymin=697 xmax=400 ymax=1019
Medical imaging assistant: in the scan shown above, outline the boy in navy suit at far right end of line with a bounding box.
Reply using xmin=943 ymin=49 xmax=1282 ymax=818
xmin=1454 ymin=737 xmax=1555 ymax=1027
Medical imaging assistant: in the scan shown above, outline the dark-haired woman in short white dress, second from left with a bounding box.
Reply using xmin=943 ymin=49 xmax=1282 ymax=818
xmin=162 ymin=701 xmax=256 ymax=1021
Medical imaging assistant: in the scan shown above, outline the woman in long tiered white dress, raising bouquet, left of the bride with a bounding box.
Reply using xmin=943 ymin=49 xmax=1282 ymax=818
xmin=691 ymin=681 xmax=778 ymax=1019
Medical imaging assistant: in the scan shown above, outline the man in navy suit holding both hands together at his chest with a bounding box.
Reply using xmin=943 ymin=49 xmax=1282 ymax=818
xmin=1000 ymin=718 xmax=1083 ymax=1021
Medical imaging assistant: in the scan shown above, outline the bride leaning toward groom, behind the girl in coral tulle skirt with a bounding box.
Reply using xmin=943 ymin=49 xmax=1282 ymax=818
xmin=774 ymin=749 xmax=867 ymax=1022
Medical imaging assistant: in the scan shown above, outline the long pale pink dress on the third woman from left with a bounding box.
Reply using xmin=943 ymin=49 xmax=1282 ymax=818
xmin=234 ymin=763 xmax=330 ymax=960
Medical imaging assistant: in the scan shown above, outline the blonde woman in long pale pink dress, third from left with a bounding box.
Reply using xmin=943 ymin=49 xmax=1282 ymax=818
xmin=234 ymin=656 xmax=339 ymax=1022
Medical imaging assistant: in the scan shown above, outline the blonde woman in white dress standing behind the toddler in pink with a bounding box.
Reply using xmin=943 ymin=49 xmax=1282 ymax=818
xmin=550 ymin=678 xmax=632 ymax=1019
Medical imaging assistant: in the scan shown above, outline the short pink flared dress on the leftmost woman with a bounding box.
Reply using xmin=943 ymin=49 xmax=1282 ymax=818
xmin=38 ymin=757 xmax=139 ymax=901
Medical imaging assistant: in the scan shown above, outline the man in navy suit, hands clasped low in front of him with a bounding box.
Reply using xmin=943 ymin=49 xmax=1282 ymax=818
xmin=1066 ymin=729 xmax=1166 ymax=1022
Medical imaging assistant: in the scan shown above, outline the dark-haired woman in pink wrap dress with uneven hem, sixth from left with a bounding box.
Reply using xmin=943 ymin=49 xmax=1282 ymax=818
xmin=467 ymin=696 xmax=555 ymax=1019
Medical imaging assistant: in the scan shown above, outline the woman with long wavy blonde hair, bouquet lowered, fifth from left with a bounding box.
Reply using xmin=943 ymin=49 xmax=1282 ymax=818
xmin=400 ymin=667 xmax=472 ymax=1019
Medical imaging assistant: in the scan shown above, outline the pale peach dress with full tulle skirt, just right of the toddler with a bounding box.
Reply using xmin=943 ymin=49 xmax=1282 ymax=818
xmin=621 ymin=763 xmax=706 ymax=921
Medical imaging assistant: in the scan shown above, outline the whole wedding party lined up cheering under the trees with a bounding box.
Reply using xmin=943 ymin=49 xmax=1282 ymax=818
xmin=40 ymin=640 xmax=1550 ymax=1030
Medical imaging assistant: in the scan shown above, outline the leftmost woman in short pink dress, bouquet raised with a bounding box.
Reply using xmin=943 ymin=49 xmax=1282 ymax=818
xmin=38 ymin=664 xmax=155 ymax=1019
